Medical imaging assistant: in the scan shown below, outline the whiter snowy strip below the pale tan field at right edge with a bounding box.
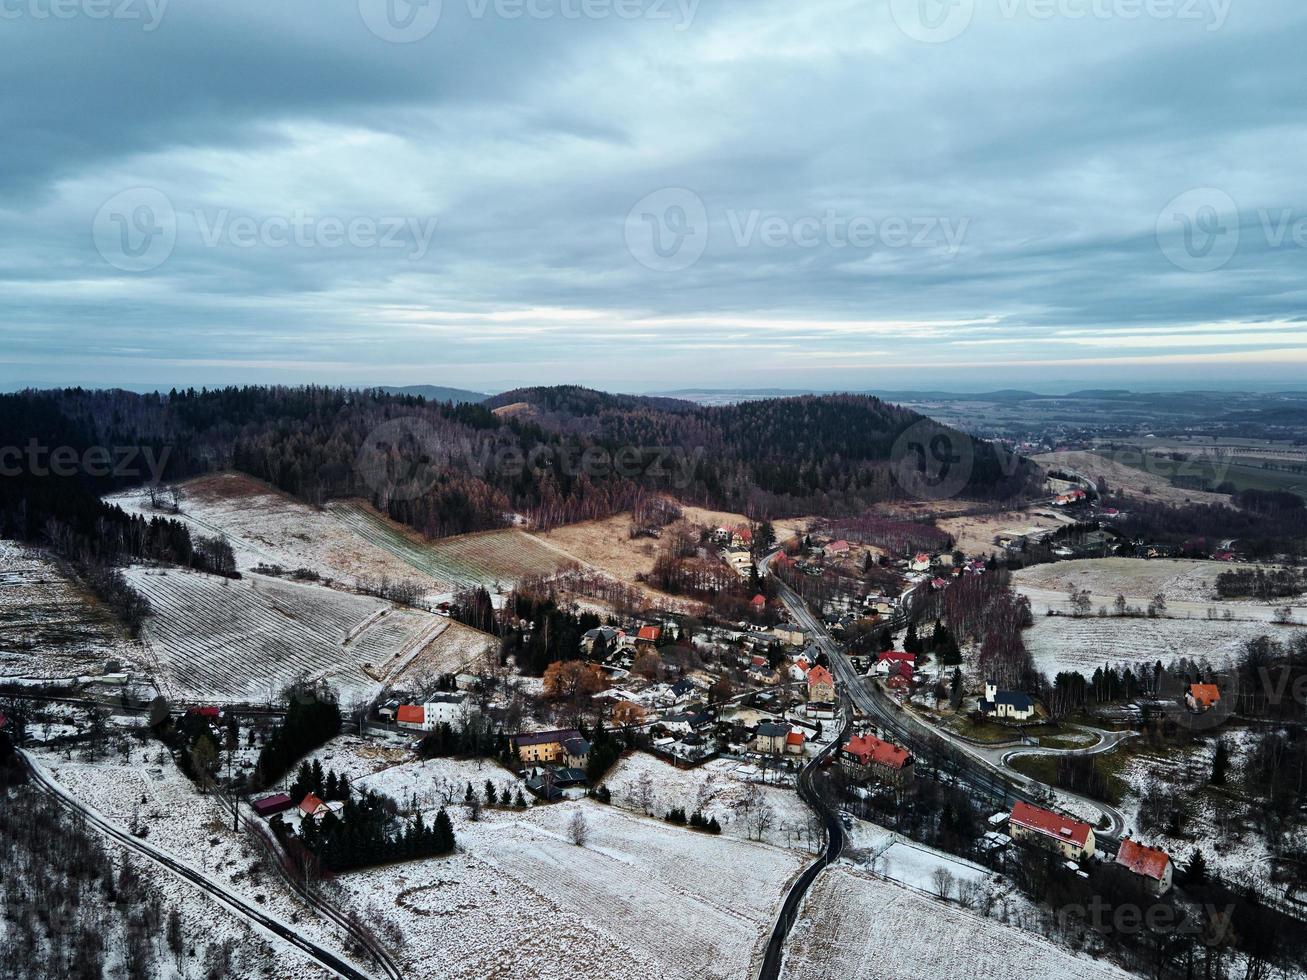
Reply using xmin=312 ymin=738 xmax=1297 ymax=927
xmin=1022 ymin=606 xmax=1303 ymax=677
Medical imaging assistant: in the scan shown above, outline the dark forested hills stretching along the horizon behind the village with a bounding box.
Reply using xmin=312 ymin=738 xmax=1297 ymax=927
xmin=0 ymin=387 xmax=1034 ymax=554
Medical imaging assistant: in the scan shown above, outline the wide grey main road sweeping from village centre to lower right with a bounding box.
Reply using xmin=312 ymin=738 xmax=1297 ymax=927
xmin=762 ymin=553 xmax=1125 ymax=840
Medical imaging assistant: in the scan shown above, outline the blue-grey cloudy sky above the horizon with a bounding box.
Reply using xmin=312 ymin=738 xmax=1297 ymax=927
xmin=0 ymin=0 xmax=1307 ymax=391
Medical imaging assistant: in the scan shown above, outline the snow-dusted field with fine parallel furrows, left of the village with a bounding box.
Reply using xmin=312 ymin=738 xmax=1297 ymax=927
xmin=128 ymin=567 xmax=444 ymax=703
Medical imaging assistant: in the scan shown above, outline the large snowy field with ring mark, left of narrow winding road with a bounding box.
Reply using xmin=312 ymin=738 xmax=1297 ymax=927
xmin=340 ymin=801 xmax=804 ymax=980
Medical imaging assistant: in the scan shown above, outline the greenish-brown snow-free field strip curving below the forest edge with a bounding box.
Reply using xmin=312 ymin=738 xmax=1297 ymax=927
xmin=327 ymin=500 xmax=569 ymax=588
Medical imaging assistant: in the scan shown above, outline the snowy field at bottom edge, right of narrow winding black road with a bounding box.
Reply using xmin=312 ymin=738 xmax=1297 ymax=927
xmin=782 ymin=865 xmax=1131 ymax=980
